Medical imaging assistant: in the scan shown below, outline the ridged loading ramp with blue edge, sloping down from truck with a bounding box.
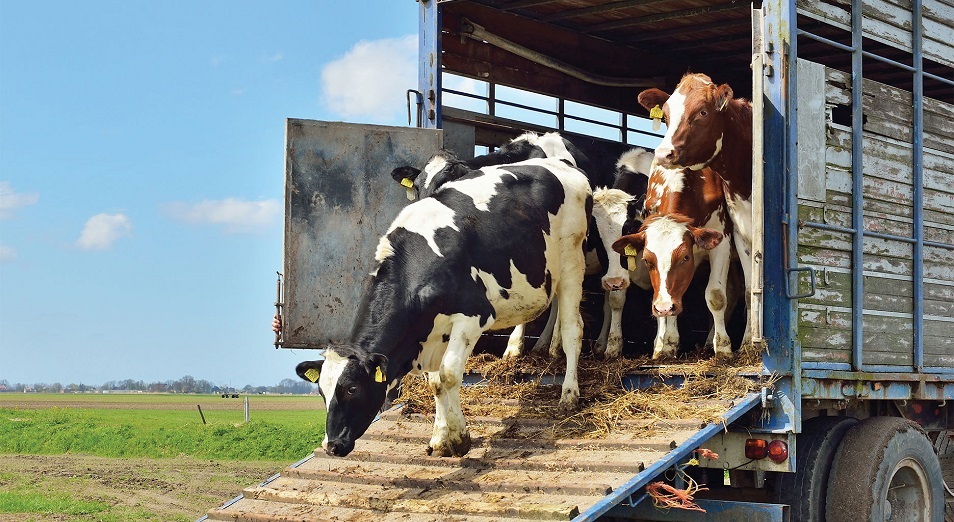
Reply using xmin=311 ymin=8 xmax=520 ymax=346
xmin=206 ymin=388 xmax=758 ymax=522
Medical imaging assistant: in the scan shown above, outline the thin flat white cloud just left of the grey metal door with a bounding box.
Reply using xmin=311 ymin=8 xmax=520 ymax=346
xmin=163 ymin=198 xmax=282 ymax=232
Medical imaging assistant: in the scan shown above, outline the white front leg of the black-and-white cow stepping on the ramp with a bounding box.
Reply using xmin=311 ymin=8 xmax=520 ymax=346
xmin=427 ymin=317 xmax=483 ymax=457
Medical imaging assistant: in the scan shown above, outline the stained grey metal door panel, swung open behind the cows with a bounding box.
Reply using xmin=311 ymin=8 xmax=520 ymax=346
xmin=282 ymin=119 xmax=442 ymax=348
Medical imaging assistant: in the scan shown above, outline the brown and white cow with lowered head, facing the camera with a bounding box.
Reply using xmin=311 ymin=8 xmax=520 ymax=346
xmin=612 ymin=165 xmax=732 ymax=359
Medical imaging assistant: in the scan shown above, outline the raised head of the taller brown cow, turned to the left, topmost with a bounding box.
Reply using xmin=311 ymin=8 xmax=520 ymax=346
xmin=638 ymin=74 xmax=732 ymax=170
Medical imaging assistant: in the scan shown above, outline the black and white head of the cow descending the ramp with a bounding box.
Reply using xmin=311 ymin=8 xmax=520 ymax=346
xmin=295 ymin=348 xmax=388 ymax=457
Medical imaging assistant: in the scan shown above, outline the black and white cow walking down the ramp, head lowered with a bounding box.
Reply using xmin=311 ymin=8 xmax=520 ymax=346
xmin=296 ymin=154 xmax=592 ymax=456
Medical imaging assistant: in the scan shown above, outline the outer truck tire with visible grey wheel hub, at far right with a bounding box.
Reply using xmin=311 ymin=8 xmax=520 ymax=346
xmin=826 ymin=417 xmax=944 ymax=522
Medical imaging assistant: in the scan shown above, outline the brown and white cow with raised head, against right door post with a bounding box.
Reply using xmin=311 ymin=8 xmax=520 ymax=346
xmin=639 ymin=74 xmax=752 ymax=346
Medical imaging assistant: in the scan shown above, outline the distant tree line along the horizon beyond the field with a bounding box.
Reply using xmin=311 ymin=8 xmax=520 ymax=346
xmin=0 ymin=375 xmax=317 ymax=395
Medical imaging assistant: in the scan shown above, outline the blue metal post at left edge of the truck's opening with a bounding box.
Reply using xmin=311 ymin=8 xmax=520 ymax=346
xmin=417 ymin=0 xmax=442 ymax=129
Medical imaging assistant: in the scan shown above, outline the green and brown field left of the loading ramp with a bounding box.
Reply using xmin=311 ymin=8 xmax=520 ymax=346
xmin=0 ymin=393 xmax=325 ymax=522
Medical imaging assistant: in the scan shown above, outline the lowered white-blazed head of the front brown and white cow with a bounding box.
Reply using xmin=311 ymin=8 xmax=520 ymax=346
xmin=613 ymin=214 xmax=725 ymax=317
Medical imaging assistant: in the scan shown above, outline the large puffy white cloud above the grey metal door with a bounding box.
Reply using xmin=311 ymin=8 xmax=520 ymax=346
xmin=321 ymin=35 xmax=417 ymax=123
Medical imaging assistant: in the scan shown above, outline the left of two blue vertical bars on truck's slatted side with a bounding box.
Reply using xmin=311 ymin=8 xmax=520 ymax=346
xmin=851 ymin=0 xmax=865 ymax=371
